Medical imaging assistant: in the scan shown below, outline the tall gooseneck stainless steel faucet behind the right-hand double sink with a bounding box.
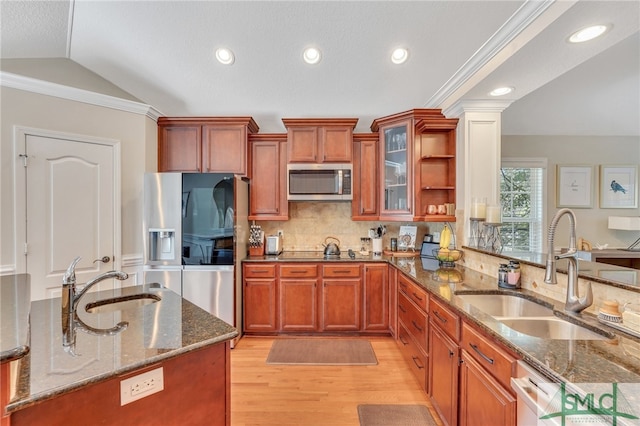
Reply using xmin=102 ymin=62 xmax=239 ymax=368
xmin=544 ymin=209 xmax=593 ymax=313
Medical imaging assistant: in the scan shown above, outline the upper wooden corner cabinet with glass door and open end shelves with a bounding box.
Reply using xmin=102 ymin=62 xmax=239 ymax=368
xmin=371 ymin=109 xmax=458 ymax=222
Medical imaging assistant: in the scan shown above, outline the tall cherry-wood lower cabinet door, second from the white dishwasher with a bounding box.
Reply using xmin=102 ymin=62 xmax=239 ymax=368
xmin=429 ymin=322 xmax=458 ymax=425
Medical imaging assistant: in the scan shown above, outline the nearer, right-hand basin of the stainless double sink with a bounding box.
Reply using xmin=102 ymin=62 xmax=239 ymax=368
xmin=496 ymin=317 xmax=611 ymax=340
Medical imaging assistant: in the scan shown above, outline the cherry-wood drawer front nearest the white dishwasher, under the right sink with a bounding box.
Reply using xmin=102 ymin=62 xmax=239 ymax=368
xmin=461 ymin=323 xmax=517 ymax=389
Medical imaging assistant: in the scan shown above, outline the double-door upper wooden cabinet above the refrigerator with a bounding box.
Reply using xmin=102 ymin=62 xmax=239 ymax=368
xmin=158 ymin=117 xmax=258 ymax=175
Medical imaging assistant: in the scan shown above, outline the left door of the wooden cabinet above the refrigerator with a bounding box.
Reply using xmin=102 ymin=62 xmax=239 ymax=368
xmin=158 ymin=125 xmax=202 ymax=173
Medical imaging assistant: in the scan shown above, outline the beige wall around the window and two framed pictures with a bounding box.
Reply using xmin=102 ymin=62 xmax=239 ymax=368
xmin=502 ymin=136 xmax=640 ymax=248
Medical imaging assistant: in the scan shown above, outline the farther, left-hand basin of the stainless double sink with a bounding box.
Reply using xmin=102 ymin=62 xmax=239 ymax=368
xmin=456 ymin=294 xmax=553 ymax=317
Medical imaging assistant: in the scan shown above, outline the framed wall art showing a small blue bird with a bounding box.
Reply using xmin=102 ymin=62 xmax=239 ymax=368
xmin=600 ymin=165 xmax=638 ymax=209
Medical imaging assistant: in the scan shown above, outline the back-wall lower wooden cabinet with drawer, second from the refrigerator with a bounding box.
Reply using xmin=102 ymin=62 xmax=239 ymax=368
xmin=278 ymin=264 xmax=318 ymax=332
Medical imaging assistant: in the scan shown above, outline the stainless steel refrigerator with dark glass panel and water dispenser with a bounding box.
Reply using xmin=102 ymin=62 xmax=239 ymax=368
xmin=143 ymin=173 xmax=249 ymax=344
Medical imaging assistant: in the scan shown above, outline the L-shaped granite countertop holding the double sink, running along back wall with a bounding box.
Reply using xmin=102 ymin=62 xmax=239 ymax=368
xmin=245 ymin=252 xmax=640 ymax=383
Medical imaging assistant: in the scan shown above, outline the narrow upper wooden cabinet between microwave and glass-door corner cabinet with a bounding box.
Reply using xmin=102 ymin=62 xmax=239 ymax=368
xmin=351 ymin=133 xmax=379 ymax=220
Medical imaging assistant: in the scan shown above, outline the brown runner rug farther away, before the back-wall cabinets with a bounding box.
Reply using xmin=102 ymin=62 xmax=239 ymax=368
xmin=267 ymin=339 xmax=378 ymax=365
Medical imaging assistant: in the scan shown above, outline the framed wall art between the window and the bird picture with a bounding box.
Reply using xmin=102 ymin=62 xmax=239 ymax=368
xmin=556 ymin=165 xmax=594 ymax=209
